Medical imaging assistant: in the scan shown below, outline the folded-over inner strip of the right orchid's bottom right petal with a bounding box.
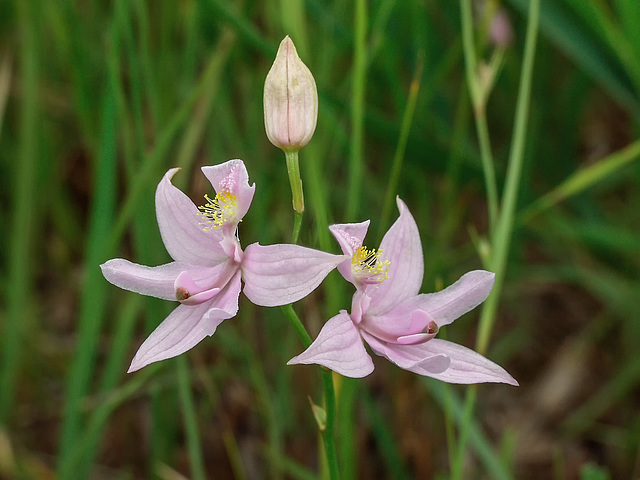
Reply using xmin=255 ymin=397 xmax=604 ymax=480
xmin=361 ymin=331 xmax=451 ymax=376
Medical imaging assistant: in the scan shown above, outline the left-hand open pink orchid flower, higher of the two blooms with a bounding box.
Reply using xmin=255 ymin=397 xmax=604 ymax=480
xmin=101 ymin=160 xmax=344 ymax=372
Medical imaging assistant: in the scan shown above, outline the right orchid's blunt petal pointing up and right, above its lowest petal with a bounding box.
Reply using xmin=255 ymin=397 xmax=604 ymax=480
xmin=414 ymin=270 xmax=495 ymax=327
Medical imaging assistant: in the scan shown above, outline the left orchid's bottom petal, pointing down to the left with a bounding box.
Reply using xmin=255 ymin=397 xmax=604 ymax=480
xmin=127 ymin=303 xmax=210 ymax=373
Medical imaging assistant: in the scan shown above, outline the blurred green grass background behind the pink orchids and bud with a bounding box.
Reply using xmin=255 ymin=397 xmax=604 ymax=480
xmin=0 ymin=0 xmax=640 ymax=480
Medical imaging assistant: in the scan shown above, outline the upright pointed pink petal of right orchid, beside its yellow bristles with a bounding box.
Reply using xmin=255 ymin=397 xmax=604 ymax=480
xmin=367 ymin=198 xmax=424 ymax=315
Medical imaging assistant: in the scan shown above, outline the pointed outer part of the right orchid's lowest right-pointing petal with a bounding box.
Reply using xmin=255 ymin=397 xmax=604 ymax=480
xmin=412 ymin=338 xmax=518 ymax=386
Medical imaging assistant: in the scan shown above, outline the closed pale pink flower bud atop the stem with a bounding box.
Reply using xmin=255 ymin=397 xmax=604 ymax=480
xmin=264 ymin=36 xmax=318 ymax=152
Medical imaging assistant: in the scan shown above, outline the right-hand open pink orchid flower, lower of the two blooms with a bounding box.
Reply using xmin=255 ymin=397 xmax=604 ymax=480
xmin=288 ymin=198 xmax=518 ymax=385
